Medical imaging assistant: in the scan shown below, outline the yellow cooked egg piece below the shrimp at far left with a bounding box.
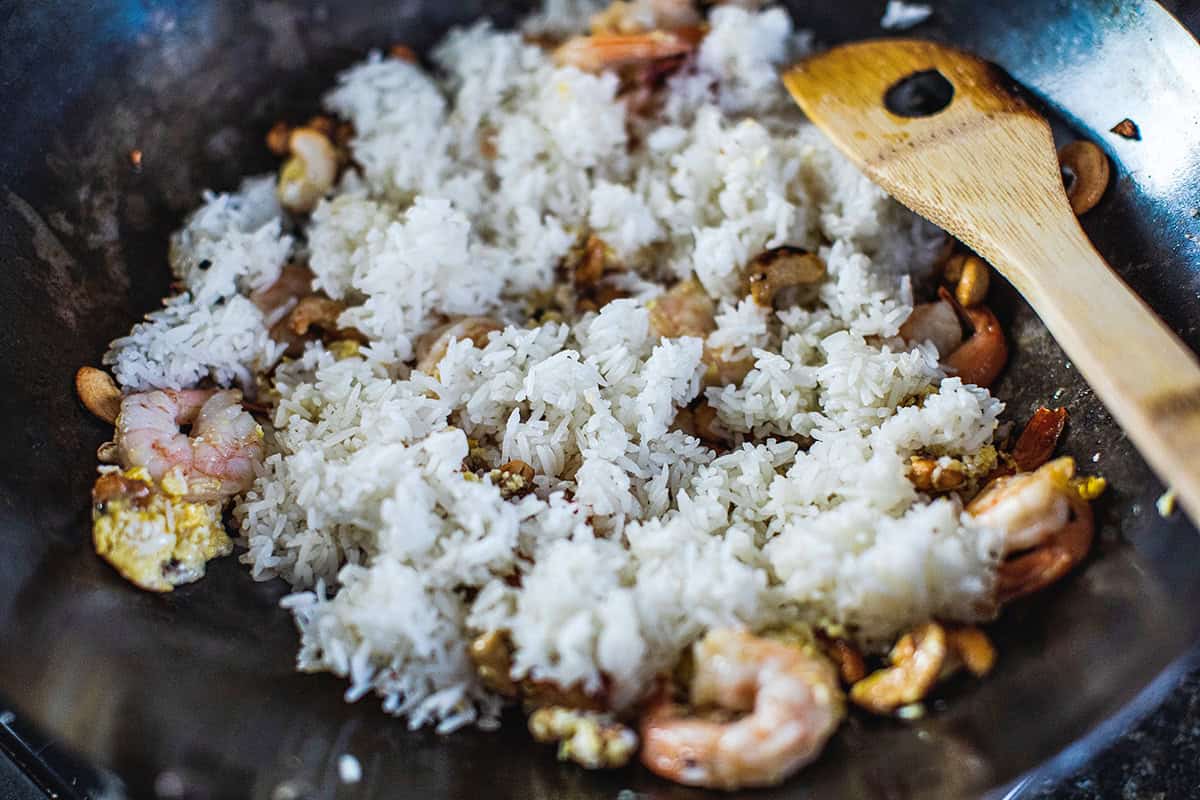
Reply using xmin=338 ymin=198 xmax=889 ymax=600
xmin=91 ymin=468 xmax=233 ymax=591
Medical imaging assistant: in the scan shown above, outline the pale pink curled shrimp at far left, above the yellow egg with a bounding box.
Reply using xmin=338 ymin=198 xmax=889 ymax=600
xmin=115 ymin=389 xmax=263 ymax=501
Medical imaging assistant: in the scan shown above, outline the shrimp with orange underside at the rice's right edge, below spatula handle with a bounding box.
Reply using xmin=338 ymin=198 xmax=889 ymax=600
xmin=967 ymin=457 xmax=1096 ymax=603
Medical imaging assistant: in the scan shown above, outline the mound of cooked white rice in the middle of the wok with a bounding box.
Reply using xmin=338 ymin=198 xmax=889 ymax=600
xmin=107 ymin=0 xmax=1002 ymax=730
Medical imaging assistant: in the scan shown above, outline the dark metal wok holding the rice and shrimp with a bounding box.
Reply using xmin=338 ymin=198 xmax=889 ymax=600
xmin=0 ymin=0 xmax=1200 ymax=800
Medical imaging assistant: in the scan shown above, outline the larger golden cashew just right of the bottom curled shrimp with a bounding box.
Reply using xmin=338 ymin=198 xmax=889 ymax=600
xmin=850 ymin=622 xmax=948 ymax=714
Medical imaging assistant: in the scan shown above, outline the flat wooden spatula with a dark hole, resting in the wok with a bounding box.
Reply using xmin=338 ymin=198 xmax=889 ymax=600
xmin=784 ymin=40 xmax=1200 ymax=522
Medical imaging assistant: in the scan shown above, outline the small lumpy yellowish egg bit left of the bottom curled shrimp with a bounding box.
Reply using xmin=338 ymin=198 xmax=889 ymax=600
xmin=529 ymin=706 xmax=637 ymax=770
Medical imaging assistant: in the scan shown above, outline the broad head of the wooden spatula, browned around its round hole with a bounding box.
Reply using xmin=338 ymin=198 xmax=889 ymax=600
xmin=784 ymin=40 xmax=1074 ymax=283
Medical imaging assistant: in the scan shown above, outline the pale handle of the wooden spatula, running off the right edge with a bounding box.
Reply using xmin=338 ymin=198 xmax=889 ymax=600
xmin=992 ymin=217 xmax=1200 ymax=519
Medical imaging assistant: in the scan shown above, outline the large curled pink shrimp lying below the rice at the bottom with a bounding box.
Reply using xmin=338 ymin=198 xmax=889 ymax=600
xmin=641 ymin=630 xmax=845 ymax=789
